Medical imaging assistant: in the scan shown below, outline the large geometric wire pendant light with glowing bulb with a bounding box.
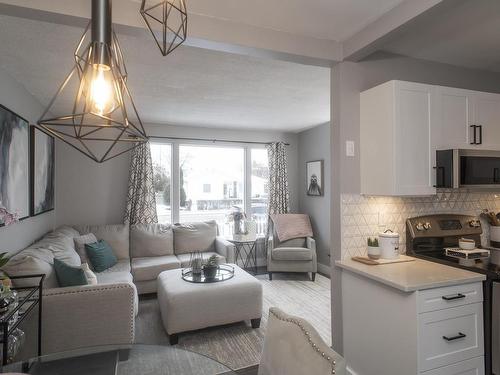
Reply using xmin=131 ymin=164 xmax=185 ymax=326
xmin=38 ymin=0 xmax=148 ymax=163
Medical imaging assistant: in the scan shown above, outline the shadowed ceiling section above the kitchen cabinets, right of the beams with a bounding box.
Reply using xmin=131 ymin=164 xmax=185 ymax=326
xmin=381 ymin=0 xmax=500 ymax=72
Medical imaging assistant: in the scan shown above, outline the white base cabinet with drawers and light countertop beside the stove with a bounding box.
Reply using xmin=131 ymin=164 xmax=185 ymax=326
xmin=336 ymin=259 xmax=485 ymax=375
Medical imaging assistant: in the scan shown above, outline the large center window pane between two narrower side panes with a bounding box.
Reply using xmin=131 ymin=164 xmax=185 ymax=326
xmin=179 ymin=145 xmax=245 ymax=232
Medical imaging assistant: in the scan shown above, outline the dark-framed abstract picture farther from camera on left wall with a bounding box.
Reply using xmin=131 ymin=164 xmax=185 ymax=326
xmin=30 ymin=126 xmax=55 ymax=216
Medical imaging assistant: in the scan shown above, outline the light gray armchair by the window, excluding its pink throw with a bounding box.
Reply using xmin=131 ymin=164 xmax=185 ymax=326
xmin=267 ymin=221 xmax=318 ymax=281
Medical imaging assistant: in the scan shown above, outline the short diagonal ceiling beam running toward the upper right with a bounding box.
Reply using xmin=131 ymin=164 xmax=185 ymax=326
xmin=343 ymin=0 xmax=443 ymax=61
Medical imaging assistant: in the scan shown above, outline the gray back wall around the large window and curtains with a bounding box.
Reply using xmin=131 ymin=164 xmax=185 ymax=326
xmin=56 ymin=125 xmax=298 ymax=225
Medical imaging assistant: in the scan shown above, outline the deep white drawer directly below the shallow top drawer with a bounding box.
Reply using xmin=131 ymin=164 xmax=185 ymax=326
xmin=418 ymin=303 xmax=484 ymax=371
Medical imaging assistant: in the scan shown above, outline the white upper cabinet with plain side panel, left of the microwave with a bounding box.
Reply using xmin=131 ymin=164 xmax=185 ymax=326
xmin=360 ymin=81 xmax=437 ymax=196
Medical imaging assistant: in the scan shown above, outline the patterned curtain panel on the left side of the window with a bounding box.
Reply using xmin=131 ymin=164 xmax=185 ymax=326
xmin=124 ymin=142 xmax=158 ymax=224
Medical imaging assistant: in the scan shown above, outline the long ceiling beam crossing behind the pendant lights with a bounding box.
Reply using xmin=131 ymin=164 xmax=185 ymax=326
xmin=0 ymin=0 xmax=342 ymax=66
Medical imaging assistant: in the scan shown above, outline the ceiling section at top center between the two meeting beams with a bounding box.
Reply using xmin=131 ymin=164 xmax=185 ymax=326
xmin=188 ymin=0 xmax=406 ymax=41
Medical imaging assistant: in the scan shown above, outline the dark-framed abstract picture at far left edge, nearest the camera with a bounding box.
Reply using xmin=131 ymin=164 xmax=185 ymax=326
xmin=0 ymin=104 xmax=30 ymax=226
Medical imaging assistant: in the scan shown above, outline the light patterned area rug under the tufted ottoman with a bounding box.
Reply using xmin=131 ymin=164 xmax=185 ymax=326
xmin=136 ymin=274 xmax=331 ymax=370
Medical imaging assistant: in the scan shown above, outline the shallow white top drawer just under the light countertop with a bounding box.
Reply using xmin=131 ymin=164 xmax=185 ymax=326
xmin=418 ymin=283 xmax=483 ymax=313
